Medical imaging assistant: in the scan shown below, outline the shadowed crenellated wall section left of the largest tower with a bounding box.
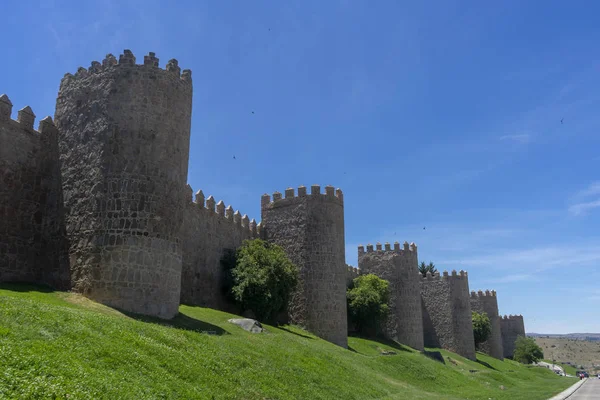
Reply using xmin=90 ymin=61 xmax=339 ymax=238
xmin=0 ymin=95 xmax=69 ymax=289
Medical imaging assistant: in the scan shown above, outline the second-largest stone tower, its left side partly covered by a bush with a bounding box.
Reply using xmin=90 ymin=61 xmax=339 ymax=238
xmin=261 ymin=185 xmax=348 ymax=347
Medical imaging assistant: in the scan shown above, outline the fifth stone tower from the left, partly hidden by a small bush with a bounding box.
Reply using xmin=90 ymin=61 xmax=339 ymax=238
xmin=471 ymin=290 xmax=504 ymax=360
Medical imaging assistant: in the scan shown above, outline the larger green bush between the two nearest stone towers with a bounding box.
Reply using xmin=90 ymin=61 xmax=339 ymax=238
xmin=231 ymin=239 xmax=298 ymax=323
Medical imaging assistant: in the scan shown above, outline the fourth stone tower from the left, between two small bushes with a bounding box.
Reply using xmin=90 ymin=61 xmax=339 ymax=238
xmin=420 ymin=271 xmax=475 ymax=360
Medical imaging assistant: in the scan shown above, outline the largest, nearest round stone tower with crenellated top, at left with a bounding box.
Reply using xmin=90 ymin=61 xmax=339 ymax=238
xmin=55 ymin=50 xmax=192 ymax=318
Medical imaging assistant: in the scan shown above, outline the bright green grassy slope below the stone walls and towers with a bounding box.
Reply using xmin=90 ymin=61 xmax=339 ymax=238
xmin=0 ymin=285 xmax=575 ymax=400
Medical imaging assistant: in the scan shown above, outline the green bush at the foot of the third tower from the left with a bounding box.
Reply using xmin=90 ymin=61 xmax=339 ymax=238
xmin=347 ymin=274 xmax=390 ymax=335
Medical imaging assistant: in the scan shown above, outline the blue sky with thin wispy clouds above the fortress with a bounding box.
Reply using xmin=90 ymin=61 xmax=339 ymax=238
xmin=0 ymin=0 xmax=600 ymax=333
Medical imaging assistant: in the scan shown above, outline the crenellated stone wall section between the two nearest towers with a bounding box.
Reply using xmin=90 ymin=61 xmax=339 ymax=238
xmin=181 ymin=188 xmax=260 ymax=310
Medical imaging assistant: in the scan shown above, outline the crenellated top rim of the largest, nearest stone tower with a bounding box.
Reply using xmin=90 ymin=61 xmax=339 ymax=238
xmin=61 ymin=49 xmax=192 ymax=86
